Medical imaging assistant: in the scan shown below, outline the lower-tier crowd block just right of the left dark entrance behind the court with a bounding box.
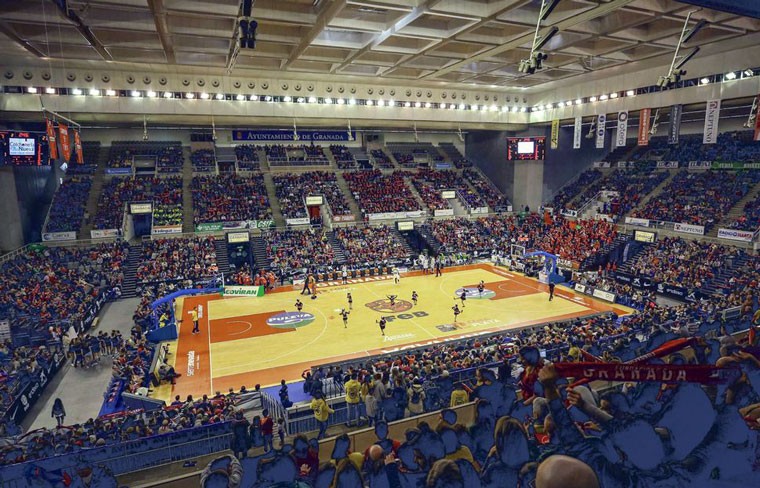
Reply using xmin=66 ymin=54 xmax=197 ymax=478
xmin=263 ymin=229 xmax=335 ymax=270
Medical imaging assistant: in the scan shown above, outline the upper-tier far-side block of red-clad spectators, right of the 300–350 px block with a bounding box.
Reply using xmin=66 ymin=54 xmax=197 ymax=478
xmin=343 ymin=169 xmax=420 ymax=217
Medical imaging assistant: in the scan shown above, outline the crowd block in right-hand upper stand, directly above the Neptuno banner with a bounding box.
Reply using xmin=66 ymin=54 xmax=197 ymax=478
xmin=631 ymin=170 xmax=760 ymax=230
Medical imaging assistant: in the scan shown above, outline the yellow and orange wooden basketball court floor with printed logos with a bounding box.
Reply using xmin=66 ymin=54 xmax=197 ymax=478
xmin=154 ymin=264 xmax=630 ymax=400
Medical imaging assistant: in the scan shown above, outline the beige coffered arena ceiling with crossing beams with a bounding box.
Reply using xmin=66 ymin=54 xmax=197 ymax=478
xmin=0 ymin=0 xmax=760 ymax=91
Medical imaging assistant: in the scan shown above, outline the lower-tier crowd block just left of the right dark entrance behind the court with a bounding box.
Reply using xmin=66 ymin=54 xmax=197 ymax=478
xmin=335 ymin=226 xmax=409 ymax=266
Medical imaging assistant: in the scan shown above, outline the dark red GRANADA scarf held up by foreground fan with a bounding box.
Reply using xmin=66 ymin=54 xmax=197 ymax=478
xmin=554 ymin=363 xmax=741 ymax=385
